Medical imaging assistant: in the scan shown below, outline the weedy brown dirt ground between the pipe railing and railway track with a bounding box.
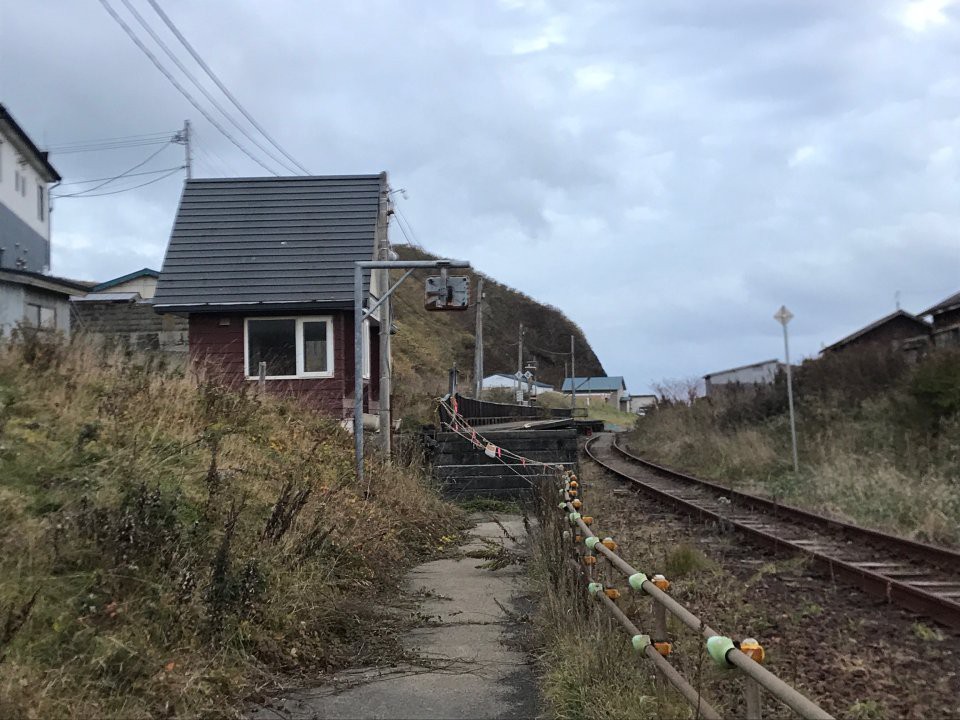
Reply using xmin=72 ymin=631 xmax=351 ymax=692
xmin=581 ymin=461 xmax=960 ymax=719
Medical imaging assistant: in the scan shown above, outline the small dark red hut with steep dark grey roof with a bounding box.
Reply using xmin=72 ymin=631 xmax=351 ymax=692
xmin=153 ymin=173 xmax=389 ymax=418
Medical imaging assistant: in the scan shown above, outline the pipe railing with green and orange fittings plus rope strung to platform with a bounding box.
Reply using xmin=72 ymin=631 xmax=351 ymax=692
xmin=440 ymin=399 xmax=832 ymax=720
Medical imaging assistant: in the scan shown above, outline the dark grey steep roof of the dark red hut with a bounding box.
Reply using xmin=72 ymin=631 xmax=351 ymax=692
xmin=153 ymin=173 xmax=386 ymax=312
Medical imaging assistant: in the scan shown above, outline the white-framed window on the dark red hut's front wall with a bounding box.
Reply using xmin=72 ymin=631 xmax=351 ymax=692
xmin=243 ymin=316 xmax=333 ymax=380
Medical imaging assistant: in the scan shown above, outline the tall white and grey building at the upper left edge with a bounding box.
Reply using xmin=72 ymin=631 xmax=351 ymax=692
xmin=0 ymin=104 xmax=61 ymax=270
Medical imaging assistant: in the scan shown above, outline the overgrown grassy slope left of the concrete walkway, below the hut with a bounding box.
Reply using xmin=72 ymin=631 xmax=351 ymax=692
xmin=0 ymin=334 xmax=460 ymax=718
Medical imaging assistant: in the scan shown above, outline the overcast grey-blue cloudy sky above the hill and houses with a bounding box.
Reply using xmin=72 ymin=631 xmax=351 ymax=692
xmin=0 ymin=0 xmax=960 ymax=392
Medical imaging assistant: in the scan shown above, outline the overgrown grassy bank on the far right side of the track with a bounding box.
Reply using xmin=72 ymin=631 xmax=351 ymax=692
xmin=628 ymin=350 xmax=960 ymax=545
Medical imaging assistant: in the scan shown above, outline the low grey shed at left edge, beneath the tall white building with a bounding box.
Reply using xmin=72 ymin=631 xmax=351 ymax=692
xmin=0 ymin=268 xmax=90 ymax=337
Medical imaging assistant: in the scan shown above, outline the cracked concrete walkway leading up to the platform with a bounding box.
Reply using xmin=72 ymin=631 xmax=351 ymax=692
xmin=251 ymin=515 xmax=537 ymax=720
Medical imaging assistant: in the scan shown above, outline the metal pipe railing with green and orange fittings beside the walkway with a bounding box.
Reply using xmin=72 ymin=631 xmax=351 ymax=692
xmin=559 ymin=470 xmax=832 ymax=720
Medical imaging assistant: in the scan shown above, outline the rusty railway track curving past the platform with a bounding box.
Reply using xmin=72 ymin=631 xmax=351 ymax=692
xmin=586 ymin=433 xmax=960 ymax=630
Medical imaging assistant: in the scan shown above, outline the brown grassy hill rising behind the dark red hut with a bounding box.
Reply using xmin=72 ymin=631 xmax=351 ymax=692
xmin=393 ymin=245 xmax=606 ymax=419
